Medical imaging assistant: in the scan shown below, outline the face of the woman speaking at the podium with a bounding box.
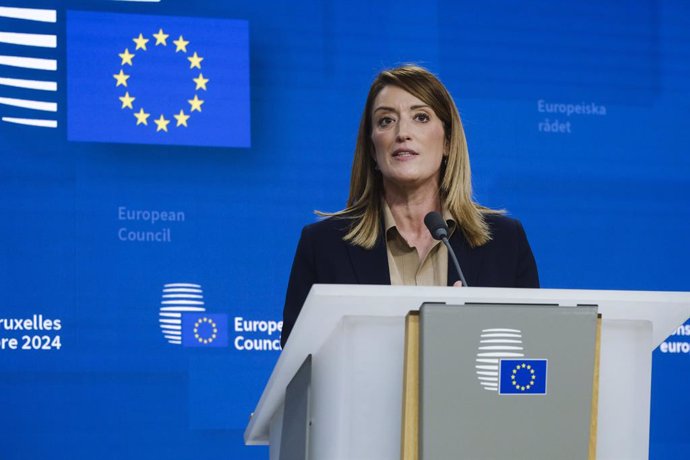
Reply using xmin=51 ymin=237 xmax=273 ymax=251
xmin=371 ymin=85 xmax=445 ymax=189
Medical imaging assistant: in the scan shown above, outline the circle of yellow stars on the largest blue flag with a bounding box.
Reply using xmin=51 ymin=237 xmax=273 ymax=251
xmin=113 ymin=29 xmax=210 ymax=133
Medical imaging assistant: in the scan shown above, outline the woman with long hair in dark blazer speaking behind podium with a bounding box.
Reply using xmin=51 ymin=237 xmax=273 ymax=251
xmin=281 ymin=65 xmax=539 ymax=345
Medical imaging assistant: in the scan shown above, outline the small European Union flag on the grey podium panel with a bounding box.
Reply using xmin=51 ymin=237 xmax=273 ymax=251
xmin=498 ymin=359 xmax=548 ymax=395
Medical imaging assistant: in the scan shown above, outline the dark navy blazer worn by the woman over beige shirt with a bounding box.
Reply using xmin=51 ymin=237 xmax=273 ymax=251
xmin=281 ymin=214 xmax=539 ymax=345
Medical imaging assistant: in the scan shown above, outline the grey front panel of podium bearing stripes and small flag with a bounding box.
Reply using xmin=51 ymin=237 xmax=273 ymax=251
xmin=420 ymin=304 xmax=597 ymax=460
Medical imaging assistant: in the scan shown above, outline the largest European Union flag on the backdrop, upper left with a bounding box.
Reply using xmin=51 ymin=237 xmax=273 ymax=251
xmin=67 ymin=11 xmax=250 ymax=147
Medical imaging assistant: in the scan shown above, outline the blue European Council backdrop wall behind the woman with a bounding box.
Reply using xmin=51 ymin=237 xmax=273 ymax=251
xmin=0 ymin=0 xmax=690 ymax=459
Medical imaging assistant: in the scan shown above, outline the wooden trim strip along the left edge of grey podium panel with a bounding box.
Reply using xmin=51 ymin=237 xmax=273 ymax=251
xmin=400 ymin=311 xmax=419 ymax=460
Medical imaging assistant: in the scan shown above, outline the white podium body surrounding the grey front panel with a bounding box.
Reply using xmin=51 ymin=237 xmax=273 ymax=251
xmin=244 ymin=285 xmax=690 ymax=460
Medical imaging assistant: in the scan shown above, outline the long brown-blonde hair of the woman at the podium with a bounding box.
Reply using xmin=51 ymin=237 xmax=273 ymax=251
xmin=317 ymin=65 xmax=501 ymax=249
